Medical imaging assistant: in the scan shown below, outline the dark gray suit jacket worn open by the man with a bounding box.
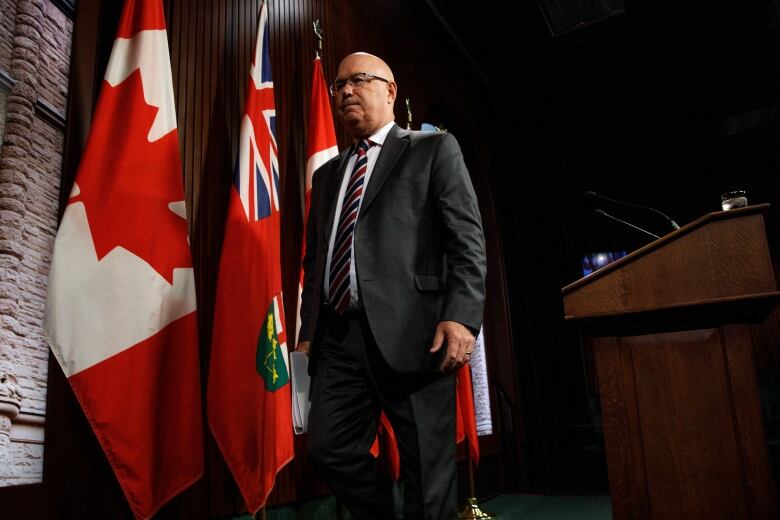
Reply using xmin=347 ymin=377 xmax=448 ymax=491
xmin=300 ymin=125 xmax=486 ymax=372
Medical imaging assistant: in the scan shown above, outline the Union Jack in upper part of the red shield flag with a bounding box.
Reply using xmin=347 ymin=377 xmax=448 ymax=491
xmin=233 ymin=5 xmax=279 ymax=221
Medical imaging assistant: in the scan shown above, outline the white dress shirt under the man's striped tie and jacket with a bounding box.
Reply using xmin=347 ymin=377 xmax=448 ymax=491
xmin=323 ymin=121 xmax=395 ymax=310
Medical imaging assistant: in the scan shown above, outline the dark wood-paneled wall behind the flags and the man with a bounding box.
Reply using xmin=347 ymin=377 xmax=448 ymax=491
xmin=0 ymin=0 xmax=524 ymax=518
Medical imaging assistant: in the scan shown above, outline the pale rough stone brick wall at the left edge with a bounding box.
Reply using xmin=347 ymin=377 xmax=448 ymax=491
xmin=0 ymin=0 xmax=73 ymax=485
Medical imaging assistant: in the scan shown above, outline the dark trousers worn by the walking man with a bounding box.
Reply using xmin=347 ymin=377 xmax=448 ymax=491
xmin=308 ymin=309 xmax=457 ymax=520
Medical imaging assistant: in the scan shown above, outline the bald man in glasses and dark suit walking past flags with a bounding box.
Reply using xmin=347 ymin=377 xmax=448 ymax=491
xmin=296 ymin=53 xmax=485 ymax=520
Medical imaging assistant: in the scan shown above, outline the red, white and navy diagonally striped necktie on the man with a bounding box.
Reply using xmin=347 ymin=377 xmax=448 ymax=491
xmin=328 ymin=139 xmax=374 ymax=314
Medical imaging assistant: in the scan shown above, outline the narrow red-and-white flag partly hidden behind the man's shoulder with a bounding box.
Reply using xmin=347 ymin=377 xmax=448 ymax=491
xmin=295 ymin=56 xmax=339 ymax=341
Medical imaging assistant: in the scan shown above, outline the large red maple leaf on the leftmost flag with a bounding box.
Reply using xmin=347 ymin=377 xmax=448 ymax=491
xmin=69 ymin=70 xmax=192 ymax=284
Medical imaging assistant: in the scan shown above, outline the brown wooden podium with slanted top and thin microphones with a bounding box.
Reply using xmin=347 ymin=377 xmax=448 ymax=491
xmin=562 ymin=204 xmax=780 ymax=520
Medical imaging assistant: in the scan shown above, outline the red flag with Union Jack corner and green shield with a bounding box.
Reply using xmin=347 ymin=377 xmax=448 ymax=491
xmin=208 ymin=3 xmax=294 ymax=513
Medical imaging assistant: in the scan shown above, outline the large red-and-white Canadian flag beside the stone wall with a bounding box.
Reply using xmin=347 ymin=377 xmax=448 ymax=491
xmin=44 ymin=0 xmax=203 ymax=518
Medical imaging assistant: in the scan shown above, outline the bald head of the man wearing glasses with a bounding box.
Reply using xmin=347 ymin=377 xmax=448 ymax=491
xmin=334 ymin=52 xmax=397 ymax=139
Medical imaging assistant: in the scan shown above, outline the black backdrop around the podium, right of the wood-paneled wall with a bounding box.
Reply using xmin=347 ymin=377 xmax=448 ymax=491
xmin=435 ymin=0 xmax=780 ymax=493
